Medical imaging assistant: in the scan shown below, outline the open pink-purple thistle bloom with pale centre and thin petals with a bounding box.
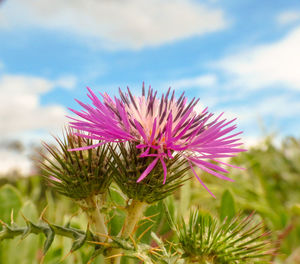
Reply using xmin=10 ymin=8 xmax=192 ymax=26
xmin=69 ymin=85 xmax=245 ymax=196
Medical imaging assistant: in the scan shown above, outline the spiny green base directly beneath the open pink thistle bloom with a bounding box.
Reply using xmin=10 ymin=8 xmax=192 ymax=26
xmin=112 ymin=142 xmax=189 ymax=204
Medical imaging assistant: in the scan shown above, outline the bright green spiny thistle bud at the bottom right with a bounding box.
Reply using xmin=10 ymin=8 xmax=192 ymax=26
xmin=176 ymin=211 xmax=274 ymax=264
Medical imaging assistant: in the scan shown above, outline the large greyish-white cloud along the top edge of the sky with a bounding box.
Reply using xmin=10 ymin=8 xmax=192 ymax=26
xmin=0 ymin=0 xmax=227 ymax=49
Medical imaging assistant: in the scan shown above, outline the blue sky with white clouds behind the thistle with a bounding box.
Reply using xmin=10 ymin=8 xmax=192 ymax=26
xmin=0 ymin=0 xmax=300 ymax=173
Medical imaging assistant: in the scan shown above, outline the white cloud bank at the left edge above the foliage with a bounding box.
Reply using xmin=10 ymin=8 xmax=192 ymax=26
xmin=0 ymin=74 xmax=76 ymax=175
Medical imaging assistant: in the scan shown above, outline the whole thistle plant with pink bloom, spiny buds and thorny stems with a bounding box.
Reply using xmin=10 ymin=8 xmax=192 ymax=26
xmin=0 ymin=86 xmax=270 ymax=264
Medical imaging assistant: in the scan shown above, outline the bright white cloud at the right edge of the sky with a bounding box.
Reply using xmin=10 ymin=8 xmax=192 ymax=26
xmin=214 ymin=27 xmax=300 ymax=90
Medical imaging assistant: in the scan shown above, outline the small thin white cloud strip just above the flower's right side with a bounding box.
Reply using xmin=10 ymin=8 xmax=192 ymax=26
xmin=170 ymin=74 xmax=217 ymax=90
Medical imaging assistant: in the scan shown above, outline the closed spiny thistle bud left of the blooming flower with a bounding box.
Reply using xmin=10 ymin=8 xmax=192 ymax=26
xmin=40 ymin=130 xmax=112 ymax=200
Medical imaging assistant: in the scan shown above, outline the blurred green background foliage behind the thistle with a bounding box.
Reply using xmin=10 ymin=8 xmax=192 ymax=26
xmin=0 ymin=137 xmax=300 ymax=264
